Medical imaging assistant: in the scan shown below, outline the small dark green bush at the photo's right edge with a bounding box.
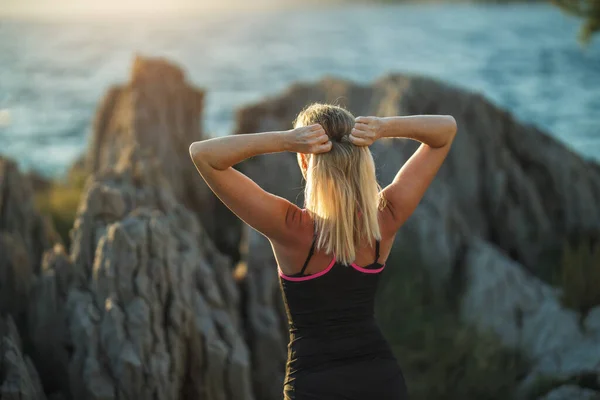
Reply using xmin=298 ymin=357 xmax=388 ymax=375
xmin=554 ymin=233 xmax=600 ymax=316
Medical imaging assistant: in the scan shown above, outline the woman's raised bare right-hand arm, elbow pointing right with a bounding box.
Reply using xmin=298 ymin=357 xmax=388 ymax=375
xmin=350 ymin=115 xmax=456 ymax=235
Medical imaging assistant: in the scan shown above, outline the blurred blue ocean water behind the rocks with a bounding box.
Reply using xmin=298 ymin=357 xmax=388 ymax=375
xmin=0 ymin=4 xmax=600 ymax=176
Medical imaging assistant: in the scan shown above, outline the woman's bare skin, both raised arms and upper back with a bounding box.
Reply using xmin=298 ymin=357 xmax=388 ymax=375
xmin=190 ymin=115 xmax=456 ymax=275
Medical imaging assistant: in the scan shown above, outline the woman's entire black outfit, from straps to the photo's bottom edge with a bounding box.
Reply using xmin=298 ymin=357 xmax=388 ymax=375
xmin=279 ymin=233 xmax=407 ymax=399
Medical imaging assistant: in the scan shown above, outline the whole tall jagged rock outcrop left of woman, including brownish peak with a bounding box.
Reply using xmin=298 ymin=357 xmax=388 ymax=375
xmin=11 ymin=58 xmax=254 ymax=400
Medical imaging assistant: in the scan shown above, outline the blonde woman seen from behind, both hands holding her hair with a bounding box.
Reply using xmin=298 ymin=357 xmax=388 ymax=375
xmin=190 ymin=104 xmax=456 ymax=400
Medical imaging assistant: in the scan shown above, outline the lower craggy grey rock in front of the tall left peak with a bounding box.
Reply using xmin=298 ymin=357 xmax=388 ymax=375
xmin=30 ymin=146 xmax=253 ymax=400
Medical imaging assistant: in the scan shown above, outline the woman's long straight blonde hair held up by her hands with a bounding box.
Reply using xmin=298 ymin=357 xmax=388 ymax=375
xmin=294 ymin=103 xmax=383 ymax=264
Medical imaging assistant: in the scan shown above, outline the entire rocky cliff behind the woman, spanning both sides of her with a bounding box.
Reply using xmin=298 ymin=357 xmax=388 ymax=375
xmin=0 ymin=57 xmax=600 ymax=400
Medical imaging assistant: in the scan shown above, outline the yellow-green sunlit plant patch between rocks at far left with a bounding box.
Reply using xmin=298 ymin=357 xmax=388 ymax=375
xmin=35 ymin=167 xmax=86 ymax=248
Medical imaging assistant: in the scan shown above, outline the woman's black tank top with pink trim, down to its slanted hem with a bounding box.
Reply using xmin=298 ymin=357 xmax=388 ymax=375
xmin=279 ymin=238 xmax=394 ymax=383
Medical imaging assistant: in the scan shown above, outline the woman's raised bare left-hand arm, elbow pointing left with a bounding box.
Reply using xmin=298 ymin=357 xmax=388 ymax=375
xmin=190 ymin=124 xmax=331 ymax=242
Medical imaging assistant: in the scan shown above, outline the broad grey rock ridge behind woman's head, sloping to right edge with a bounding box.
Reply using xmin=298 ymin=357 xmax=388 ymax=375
xmin=236 ymin=75 xmax=600 ymax=398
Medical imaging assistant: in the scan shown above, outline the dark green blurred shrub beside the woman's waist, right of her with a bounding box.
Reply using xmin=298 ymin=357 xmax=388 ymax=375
xmin=377 ymin=245 xmax=528 ymax=400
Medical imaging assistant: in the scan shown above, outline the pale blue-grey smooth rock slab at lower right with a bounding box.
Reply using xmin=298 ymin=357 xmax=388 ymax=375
xmin=460 ymin=239 xmax=600 ymax=398
